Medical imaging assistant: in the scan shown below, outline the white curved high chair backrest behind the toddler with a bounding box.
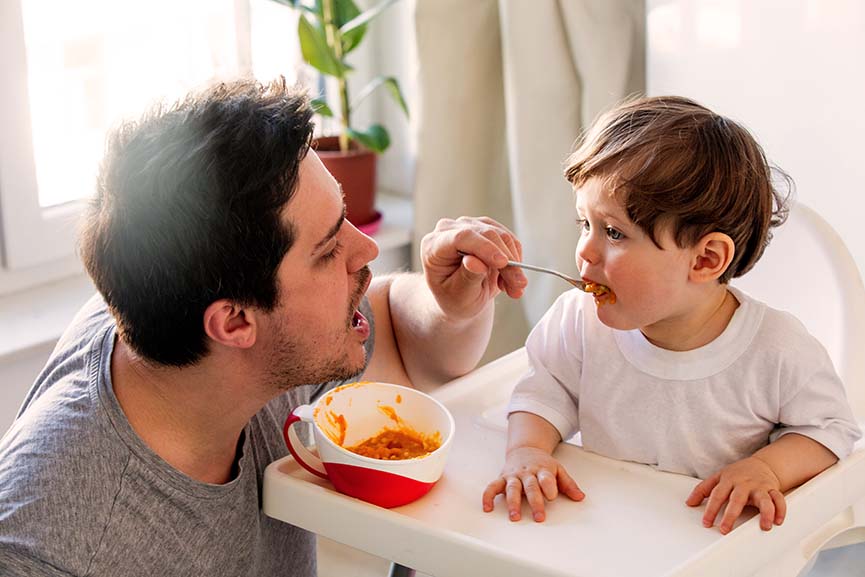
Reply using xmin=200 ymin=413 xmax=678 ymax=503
xmin=731 ymin=203 xmax=865 ymax=422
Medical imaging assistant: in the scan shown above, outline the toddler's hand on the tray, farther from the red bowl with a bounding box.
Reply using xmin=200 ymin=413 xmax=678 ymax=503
xmin=685 ymin=457 xmax=787 ymax=535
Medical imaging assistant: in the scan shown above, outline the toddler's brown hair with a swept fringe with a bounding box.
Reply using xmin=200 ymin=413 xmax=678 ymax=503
xmin=565 ymin=96 xmax=792 ymax=283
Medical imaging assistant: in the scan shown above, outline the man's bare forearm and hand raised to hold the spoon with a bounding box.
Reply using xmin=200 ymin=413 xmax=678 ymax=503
xmin=365 ymin=218 xmax=526 ymax=388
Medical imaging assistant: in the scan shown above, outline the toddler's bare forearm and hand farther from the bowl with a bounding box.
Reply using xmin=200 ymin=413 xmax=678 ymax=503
xmin=686 ymin=433 xmax=838 ymax=534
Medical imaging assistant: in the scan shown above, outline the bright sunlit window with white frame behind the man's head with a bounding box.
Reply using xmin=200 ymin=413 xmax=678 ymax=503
xmin=0 ymin=0 xmax=301 ymax=286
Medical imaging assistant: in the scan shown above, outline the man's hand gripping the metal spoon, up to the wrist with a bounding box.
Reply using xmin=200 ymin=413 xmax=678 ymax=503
xmin=421 ymin=217 xmax=527 ymax=320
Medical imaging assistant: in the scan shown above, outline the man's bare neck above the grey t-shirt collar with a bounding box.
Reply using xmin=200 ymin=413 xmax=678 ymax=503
xmin=111 ymin=339 xmax=267 ymax=484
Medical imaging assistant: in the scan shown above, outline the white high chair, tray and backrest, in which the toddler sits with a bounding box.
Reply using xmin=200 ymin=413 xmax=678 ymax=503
xmin=263 ymin=204 xmax=865 ymax=577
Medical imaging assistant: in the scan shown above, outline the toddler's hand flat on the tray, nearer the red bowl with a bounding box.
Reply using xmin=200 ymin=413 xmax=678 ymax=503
xmin=483 ymin=447 xmax=586 ymax=523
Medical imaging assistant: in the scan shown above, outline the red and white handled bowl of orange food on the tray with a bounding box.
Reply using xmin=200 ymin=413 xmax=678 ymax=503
xmin=283 ymin=382 xmax=454 ymax=507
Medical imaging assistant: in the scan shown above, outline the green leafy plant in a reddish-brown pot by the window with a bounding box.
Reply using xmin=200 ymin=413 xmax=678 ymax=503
xmin=274 ymin=0 xmax=408 ymax=226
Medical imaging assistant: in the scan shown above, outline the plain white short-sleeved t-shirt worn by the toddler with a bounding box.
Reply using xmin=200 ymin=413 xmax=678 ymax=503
xmin=508 ymin=287 xmax=862 ymax=479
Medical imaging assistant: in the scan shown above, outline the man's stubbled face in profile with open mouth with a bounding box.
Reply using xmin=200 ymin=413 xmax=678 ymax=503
xmin=258 ymin=151 xmax=378 ymax=389
